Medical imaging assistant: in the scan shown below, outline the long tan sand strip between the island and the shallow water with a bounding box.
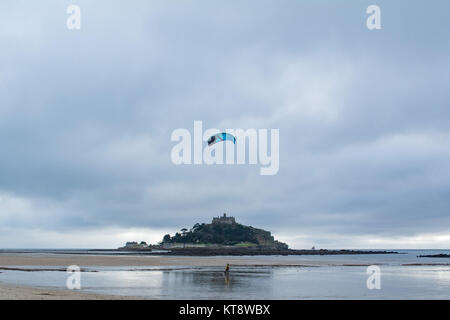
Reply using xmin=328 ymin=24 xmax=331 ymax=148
xmin=0 ymin=253 xmax=449 ymax=272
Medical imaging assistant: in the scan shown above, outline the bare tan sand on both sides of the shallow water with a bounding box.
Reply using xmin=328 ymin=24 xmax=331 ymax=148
xmin=0 ymin=253 xmax=317 ymax=300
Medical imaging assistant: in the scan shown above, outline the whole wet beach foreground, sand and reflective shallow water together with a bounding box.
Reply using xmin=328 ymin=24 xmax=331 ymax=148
xmin=0 ymin=252 xmax=449 ymax=300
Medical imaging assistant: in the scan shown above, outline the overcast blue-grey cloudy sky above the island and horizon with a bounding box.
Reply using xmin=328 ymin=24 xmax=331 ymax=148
xmin=0 ymin=0 xmax=450 ymax=248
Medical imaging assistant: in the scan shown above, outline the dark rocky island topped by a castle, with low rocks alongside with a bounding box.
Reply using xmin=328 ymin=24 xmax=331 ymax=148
xmin=118 ymin=213 xmax=397 ymax=256
